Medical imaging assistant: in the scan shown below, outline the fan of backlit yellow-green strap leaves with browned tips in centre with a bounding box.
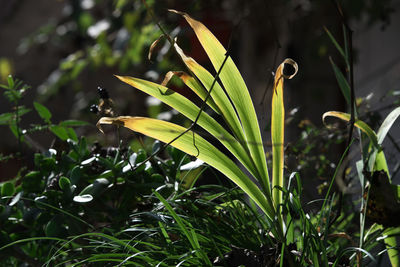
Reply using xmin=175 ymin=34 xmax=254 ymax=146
xmin=98 ymin=11 xmax=297 ymax=242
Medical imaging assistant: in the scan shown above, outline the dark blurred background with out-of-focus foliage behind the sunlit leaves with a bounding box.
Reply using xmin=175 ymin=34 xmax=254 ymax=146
xmin=0 ymin=0 xmax=400 ymax=197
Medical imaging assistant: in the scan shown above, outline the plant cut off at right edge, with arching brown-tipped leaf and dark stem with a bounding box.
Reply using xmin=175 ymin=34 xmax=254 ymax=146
xmin=322 ymin=11 xmax=400 ymax=266
